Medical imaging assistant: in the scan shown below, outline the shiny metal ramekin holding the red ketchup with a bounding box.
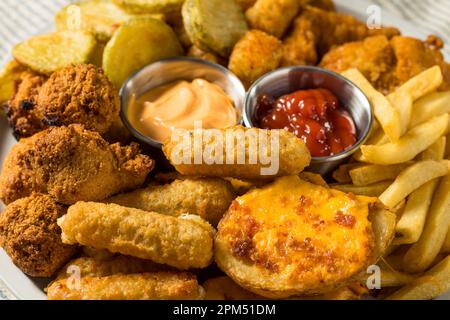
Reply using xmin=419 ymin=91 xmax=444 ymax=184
xmin=244 ymin=66 xmax=373 ymax=175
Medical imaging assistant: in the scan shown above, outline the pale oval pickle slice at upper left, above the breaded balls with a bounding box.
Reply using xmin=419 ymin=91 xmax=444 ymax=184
xmin=12 ymin=30 xmax=99 ymax=74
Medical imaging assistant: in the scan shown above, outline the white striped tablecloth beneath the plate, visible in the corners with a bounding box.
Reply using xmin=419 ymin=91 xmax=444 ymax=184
xmin=0 ymin=0 xmax=450 ymax=300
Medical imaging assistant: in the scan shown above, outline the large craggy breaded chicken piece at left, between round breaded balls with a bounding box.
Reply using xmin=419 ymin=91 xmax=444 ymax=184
xmin=0 ymin=125 xmax=154 ymax=204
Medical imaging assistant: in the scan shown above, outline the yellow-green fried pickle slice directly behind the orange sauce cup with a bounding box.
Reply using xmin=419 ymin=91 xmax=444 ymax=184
xmin=103 ymin=17 xmax=183 ymax=88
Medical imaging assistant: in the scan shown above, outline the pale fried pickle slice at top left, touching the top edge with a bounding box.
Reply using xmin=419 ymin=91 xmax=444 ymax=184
xmin=55 ymin=0 xmax=163 ymax=42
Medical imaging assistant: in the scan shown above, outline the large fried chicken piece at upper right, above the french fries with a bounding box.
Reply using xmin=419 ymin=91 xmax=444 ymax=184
xmin=320 ymin=36 xmax=450 ymax=94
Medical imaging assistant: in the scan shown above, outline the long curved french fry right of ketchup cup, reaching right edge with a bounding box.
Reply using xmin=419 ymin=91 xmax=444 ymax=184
xmin=361 ymin=114 xmax=449 ymax=165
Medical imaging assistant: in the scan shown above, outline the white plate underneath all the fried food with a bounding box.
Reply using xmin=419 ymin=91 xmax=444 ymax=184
xmin=0 ymin=0 xmax=450 ymax=300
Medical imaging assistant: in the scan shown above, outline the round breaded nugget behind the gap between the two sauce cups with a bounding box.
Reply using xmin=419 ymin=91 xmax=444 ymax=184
xmin=228 ymin=30 xmax=283 ymax=88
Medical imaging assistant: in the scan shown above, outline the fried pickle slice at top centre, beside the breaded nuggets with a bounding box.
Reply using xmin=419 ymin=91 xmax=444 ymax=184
xmin=182 ymin=0 xmax=248 ymax=57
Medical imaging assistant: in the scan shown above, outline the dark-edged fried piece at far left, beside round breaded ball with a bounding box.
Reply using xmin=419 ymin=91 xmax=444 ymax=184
xmin=5 ymin=70 xmax=47 ymax=139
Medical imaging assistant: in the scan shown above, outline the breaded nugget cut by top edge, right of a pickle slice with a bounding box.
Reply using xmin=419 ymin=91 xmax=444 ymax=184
xmin=245 ymin=0 xmax=300 ymax=38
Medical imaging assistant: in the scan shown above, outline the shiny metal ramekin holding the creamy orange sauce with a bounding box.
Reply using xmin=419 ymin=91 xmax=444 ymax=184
xmin=120 ymin=57 xmax=245 ymax=149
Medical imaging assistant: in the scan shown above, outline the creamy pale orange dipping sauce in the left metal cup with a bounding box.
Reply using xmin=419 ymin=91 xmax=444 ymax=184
xmin=128 ymin=79 xmax=238 ymax=141
